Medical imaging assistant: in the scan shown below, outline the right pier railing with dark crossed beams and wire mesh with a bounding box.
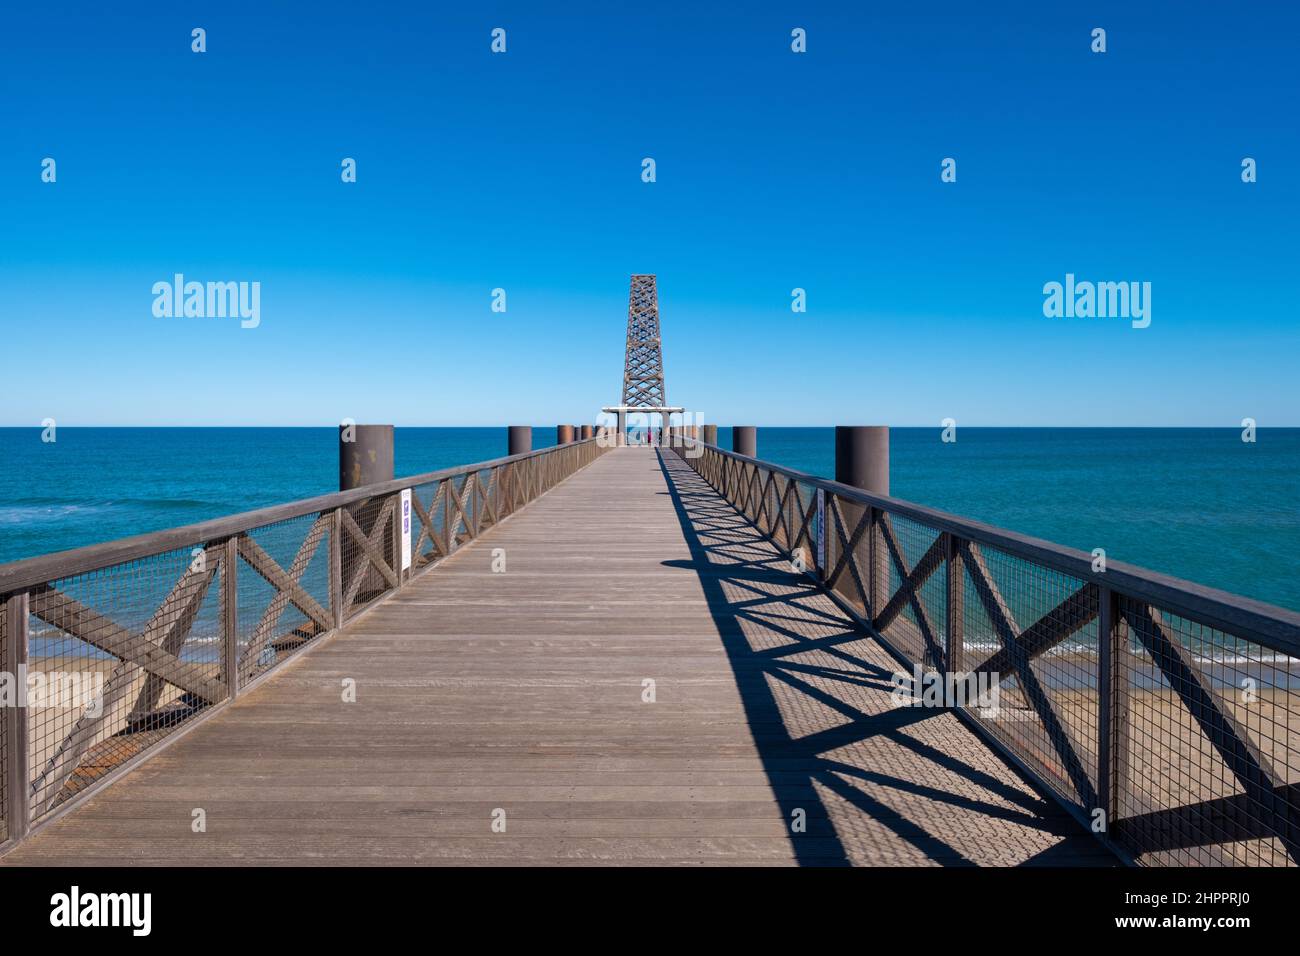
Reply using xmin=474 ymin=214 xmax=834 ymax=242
xmin=679 ymin=442 xmax=1300 ymax=866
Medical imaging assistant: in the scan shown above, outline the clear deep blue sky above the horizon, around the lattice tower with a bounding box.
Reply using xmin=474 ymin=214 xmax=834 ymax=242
xmin=0 ymin=3 xmax=1300 ymax=427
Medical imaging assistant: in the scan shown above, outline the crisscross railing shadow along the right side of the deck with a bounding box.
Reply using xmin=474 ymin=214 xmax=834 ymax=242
xmin=659 ymin=451 xmax=1117 ymax=866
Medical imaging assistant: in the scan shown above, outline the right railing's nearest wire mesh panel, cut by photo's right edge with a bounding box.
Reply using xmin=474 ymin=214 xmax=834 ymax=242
xmin=1115 ymin=597 xmax=1300 ymax=866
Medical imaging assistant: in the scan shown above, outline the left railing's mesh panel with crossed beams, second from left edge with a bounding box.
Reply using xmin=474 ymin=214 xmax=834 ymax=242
xmin=235 ymin=511 xmax=334 ymax=687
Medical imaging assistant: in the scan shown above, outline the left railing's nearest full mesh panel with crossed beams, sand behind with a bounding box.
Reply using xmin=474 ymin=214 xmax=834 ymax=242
xmin=26 ymin=546 xmax=228 ymax=822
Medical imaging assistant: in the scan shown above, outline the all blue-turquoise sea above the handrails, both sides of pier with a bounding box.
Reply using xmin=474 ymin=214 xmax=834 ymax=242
xmin=0 ymin=425 xmax=1300 ymax=610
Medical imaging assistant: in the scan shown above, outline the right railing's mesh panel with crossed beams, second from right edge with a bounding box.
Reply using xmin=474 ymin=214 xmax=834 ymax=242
xmin=962 ymin=544 xmax=1101 ymax=813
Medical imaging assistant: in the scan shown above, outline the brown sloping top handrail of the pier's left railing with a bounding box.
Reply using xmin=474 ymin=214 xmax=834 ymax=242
xmin=0 ymin=437 xmax=598 ymax=596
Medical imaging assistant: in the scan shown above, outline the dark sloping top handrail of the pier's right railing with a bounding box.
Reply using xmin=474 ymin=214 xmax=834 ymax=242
xmin=696 ymin=440 xmax=1300 ymax=657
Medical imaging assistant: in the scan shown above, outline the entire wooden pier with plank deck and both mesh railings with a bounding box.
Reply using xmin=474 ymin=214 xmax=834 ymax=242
xmin=0 ymin=428 xmax=1300 ymax=866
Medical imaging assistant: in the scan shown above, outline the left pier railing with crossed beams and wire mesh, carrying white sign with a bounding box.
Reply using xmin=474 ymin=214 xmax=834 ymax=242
xmin=0 ymin=438 xmax=606 ymax=848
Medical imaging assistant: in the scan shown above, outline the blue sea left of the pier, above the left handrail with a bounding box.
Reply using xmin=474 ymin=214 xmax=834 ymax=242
xmin=0 ymin=425 xmax=555 ymax=562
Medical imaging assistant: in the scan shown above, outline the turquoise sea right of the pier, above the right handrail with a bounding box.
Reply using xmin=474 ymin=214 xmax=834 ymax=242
xmin=718 ymin=428 xmax=1300 ymax=610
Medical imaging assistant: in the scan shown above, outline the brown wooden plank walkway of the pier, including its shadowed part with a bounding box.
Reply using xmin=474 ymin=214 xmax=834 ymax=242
xmin=0 ymin=449 xmax=1114 ymax=865
